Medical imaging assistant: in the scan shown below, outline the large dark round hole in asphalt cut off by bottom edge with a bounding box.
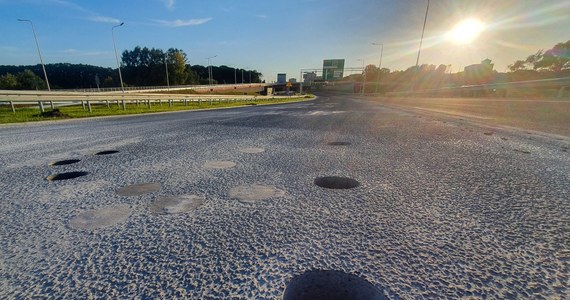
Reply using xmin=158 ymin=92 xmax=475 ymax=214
xmin=283 ymin=270 xmax=387 ymax=300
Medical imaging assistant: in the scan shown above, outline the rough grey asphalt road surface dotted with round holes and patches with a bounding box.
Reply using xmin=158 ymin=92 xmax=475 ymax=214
xmin=0 ymin=94 xmax=570 ymax=299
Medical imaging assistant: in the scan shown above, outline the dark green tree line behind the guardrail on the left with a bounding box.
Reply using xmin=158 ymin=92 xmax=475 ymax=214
xmin=0 ymin=46 xmax=262 ymax=90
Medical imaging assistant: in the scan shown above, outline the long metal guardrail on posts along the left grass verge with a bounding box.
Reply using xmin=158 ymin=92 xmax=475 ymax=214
xmin=0 ymin=90 xmax=287 ymax=113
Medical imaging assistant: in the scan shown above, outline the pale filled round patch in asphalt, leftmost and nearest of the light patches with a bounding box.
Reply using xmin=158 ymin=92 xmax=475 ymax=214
xmin=69 ymin=205 xmax=131 ymax=230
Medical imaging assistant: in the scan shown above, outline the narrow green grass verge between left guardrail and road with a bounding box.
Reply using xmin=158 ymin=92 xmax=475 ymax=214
xmin=0 ymin=95 xmax=314 ymax=124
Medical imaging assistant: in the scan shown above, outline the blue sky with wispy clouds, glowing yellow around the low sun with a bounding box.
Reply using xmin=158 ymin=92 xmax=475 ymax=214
xmin=0 ymin=0 xmax=570 ymax=82
